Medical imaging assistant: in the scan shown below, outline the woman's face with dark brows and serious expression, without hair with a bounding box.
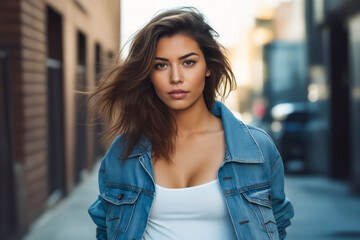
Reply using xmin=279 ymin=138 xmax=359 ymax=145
xmin=150 ymin=34 xmax=210 ymax=110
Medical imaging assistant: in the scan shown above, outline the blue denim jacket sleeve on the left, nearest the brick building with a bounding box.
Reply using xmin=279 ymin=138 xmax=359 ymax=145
xmin=88 ymin=160 xmax=107 ymax=240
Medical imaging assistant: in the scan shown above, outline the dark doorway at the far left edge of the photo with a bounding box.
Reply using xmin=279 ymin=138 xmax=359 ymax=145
xmin=0 ymin=49 xmax=16 ymax=239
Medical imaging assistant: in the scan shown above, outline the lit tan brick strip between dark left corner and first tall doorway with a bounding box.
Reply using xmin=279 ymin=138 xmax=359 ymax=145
xmin=19 ymin=0 xmax=48 ymax=225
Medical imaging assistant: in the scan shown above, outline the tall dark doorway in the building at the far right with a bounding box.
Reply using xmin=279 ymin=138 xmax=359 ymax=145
xmin=329 ymin=19 xmax=350 ymax=179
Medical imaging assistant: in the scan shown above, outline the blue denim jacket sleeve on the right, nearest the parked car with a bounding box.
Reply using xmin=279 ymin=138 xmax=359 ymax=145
xmin=271 ymin=149 xmax=294 ymax=240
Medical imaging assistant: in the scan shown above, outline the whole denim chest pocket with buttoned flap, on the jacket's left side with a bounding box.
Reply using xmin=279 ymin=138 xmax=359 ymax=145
xmin=101 ymin=187 xmax=140 ymax=234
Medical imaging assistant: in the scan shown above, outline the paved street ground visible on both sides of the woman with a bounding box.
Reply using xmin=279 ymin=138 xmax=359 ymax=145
xmin=23 ymin=163 xmax=360 ymax=240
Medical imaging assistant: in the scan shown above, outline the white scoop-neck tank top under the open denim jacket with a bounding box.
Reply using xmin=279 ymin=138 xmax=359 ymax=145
xmin=143 ymin=179 xmax=236 ymax=240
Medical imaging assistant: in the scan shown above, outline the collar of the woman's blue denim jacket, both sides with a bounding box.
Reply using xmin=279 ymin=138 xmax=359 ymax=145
xmin=124 ymin=101 xmax=264 ymax=163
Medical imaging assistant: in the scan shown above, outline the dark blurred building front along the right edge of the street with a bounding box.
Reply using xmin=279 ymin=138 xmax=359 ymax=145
xmin=305 ymin=0 xmax=360 ymax=192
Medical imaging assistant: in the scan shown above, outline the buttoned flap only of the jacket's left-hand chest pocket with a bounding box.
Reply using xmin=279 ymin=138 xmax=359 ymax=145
xmin=101 ymin=187 xmax=140 ymax=205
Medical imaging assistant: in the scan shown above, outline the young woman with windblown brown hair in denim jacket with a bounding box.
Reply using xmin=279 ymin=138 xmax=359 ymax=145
xmin=89 ymin=8 xmax=293 ymax=240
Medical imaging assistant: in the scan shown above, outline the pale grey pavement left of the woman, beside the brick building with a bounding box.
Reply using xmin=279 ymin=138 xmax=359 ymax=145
xmin=23 ymin=164 xmax=100 ymax=240
